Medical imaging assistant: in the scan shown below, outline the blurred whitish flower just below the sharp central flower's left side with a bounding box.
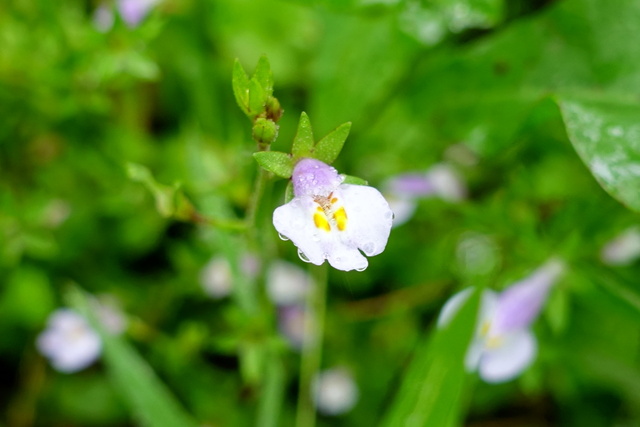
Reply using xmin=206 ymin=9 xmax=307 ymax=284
xmin=267 ymin=261 xmax=311 ymax=305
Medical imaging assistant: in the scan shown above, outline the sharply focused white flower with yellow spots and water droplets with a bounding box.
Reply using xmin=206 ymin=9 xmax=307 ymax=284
xmin=273 ymin=159 xmax=393 ymax=271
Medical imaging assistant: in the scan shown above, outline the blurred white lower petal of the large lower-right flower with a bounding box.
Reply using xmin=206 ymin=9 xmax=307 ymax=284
xmin=479 ymin=330 xmax=538 ymax=383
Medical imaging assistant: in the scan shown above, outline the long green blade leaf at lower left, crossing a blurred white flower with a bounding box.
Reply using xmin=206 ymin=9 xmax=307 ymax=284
xmin=67 ymin=287 xmax=197 ymax=427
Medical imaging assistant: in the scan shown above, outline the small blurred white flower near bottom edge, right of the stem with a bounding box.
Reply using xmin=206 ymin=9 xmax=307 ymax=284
xmin=313 ymin=368 xmax=359 ymax=415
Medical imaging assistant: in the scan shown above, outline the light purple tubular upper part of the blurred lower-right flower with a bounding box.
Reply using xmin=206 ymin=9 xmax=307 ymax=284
xmin=491 ymin=260 xmax=564 ymax=335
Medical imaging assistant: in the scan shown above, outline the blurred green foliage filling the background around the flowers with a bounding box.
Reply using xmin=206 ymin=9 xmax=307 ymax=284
xmin=0 ymin=0 xmax=640 ymax=426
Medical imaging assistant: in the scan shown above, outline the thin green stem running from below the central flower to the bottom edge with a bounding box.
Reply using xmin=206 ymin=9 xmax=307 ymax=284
xmin=296 ymin=264 xmax=328 ymax=427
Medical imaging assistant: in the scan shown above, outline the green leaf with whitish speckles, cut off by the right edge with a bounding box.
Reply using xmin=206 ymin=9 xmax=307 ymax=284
xmin=558 ymin=97 xmax=640 ymax=211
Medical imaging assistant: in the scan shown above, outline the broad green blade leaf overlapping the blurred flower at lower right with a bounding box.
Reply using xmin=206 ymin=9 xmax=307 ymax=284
xmin=382 ymin=289 xmax=480 ymax=427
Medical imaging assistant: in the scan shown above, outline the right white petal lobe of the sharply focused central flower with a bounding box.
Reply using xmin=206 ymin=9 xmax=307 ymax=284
xmin=339 ymin=184 xmax=393 ymax=256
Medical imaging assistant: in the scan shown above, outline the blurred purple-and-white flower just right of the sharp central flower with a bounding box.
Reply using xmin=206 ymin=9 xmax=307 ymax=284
xmin=382 ymin=163 xmax=467 ymax=226
